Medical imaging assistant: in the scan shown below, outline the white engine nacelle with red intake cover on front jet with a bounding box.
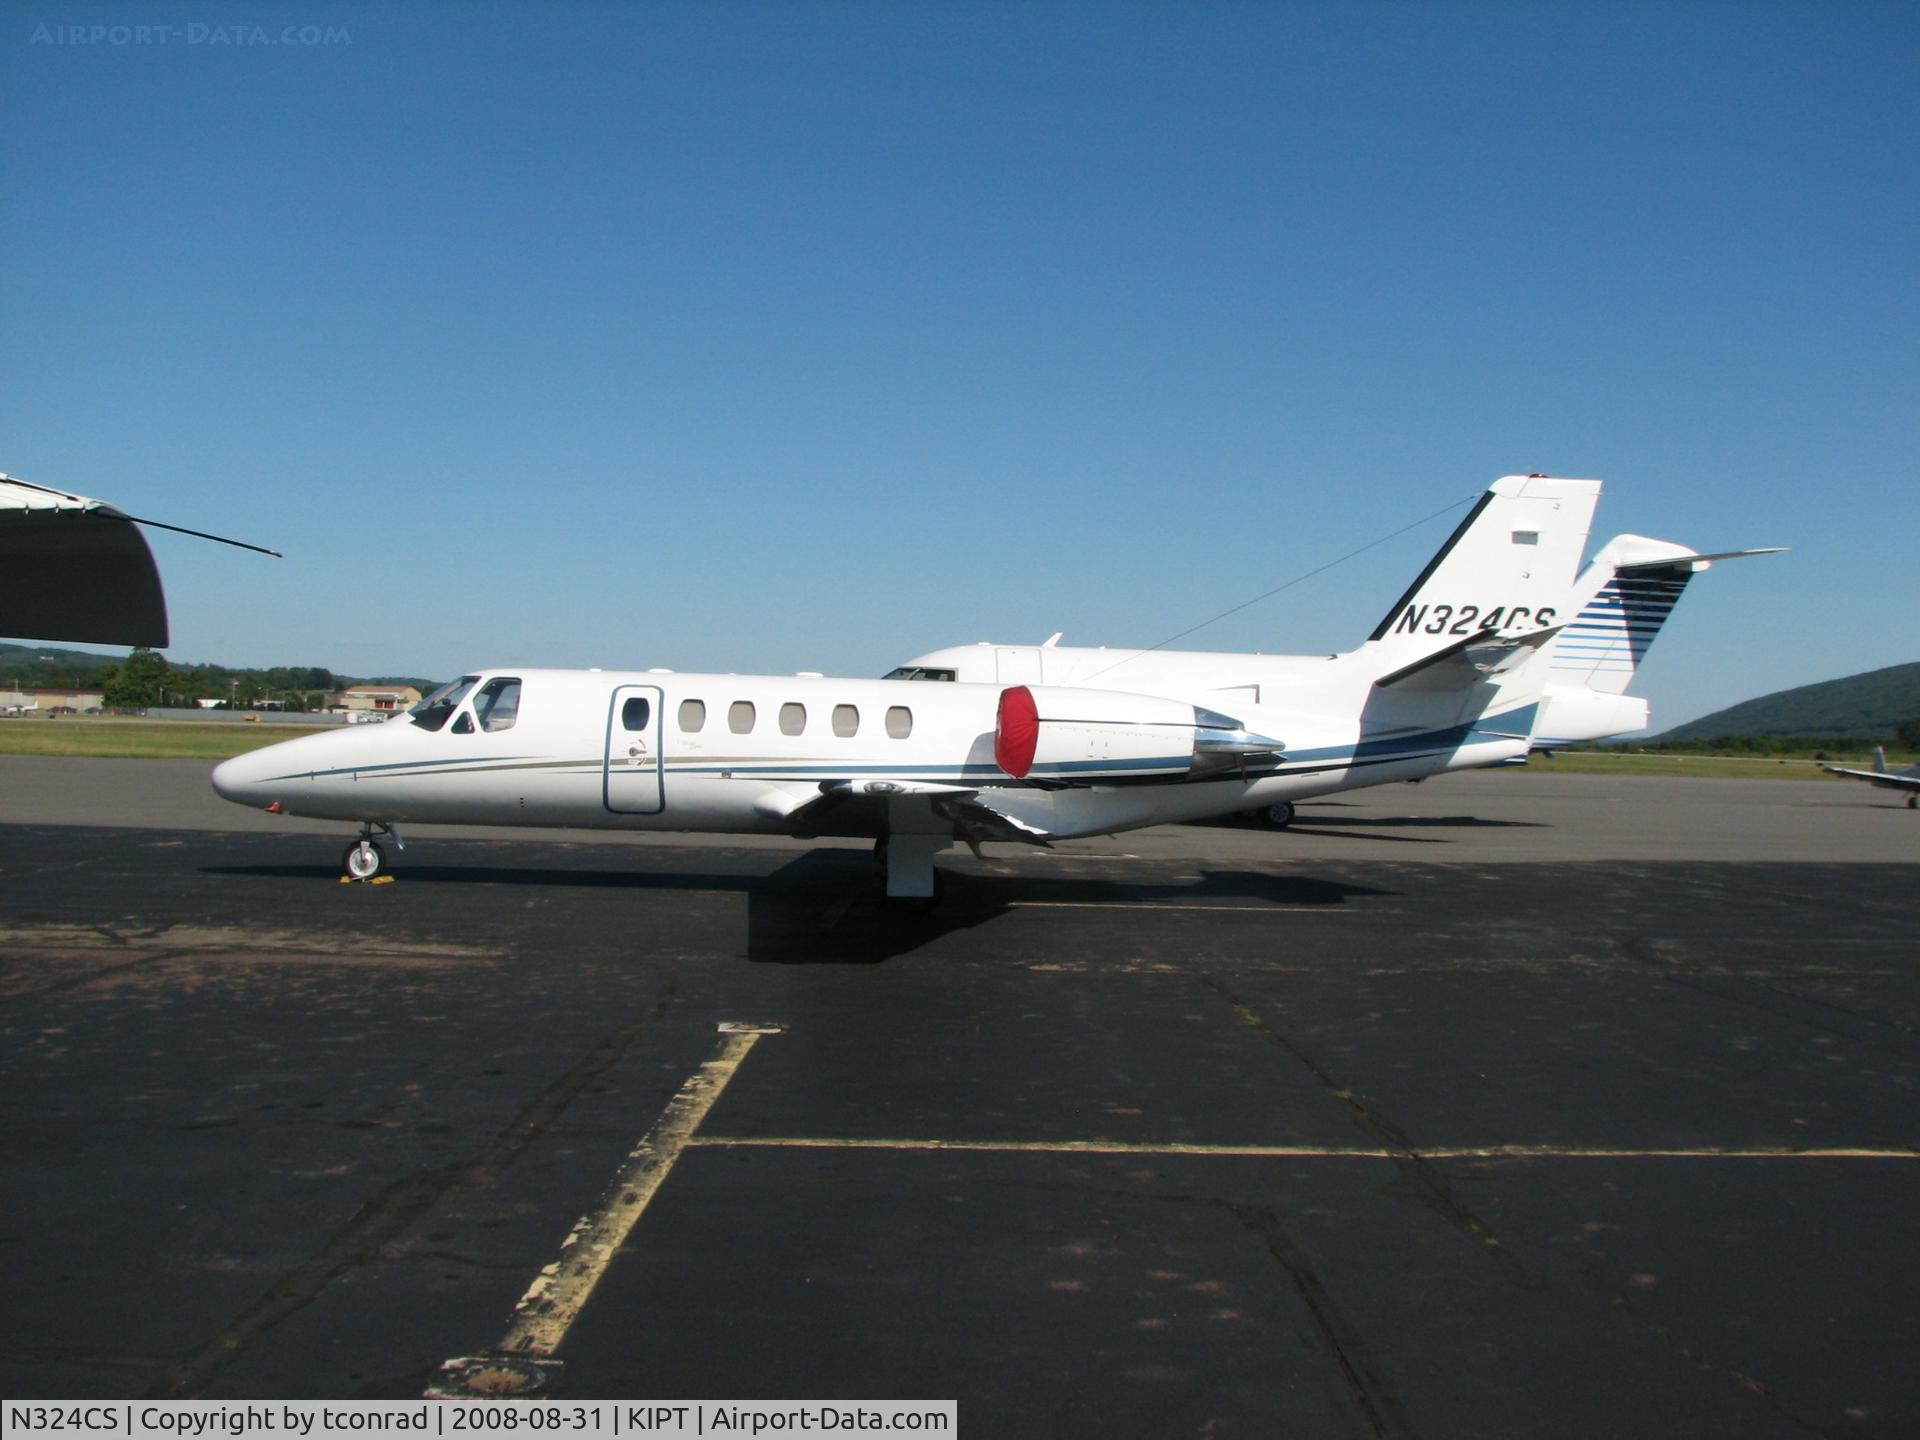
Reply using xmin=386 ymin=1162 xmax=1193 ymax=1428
xmin=993 ymin=685 xmax=1283 ymax=785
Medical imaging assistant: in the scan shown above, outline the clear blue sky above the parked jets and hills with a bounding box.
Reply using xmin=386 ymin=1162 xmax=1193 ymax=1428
xmin=0 ymin=0 xmax=1920 ymax=728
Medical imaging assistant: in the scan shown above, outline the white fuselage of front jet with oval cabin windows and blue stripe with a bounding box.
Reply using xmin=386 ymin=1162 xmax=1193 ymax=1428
xmin=213 ymin=668 xmax=1526 ymax=841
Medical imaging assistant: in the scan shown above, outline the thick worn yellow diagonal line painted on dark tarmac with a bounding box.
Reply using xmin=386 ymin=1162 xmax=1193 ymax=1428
xmin=495 ymin=1025 xmax=778 ymax=1356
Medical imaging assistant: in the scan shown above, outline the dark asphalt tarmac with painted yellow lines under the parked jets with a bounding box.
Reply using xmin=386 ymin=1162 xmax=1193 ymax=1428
xmin=0 ymin=758 xmax=1920 ymax=1436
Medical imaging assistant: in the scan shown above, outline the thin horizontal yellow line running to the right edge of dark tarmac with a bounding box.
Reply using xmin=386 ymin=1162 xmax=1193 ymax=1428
xmin=687 ymin=1135 xmax=1920 ymax=1160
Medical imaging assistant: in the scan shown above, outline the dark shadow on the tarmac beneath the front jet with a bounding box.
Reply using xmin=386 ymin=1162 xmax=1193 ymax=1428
xmin=202 ymin=851 xmax=1392 ymax=966
